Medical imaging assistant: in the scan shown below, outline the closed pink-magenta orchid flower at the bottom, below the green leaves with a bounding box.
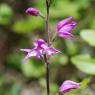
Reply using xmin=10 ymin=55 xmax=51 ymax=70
xmin=59 ymin=80 xmax=80 ymax=93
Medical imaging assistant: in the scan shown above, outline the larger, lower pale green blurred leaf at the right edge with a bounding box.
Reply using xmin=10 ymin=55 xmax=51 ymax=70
xmin=72 ymin=54 xmax=95 ymax=75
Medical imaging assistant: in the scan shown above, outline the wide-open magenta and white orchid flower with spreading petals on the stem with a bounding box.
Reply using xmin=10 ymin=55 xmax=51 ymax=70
xmin=21 ymin=39 xmax=60 ymax=62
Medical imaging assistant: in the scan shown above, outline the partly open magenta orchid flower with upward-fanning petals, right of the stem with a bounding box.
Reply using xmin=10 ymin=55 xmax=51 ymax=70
xmin=57 ymin=17 xmax=77 ymax=38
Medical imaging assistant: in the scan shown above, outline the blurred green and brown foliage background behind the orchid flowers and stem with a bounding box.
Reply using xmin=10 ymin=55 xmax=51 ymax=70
xmin=0 ymin=0 xmax=95 ymax=95
